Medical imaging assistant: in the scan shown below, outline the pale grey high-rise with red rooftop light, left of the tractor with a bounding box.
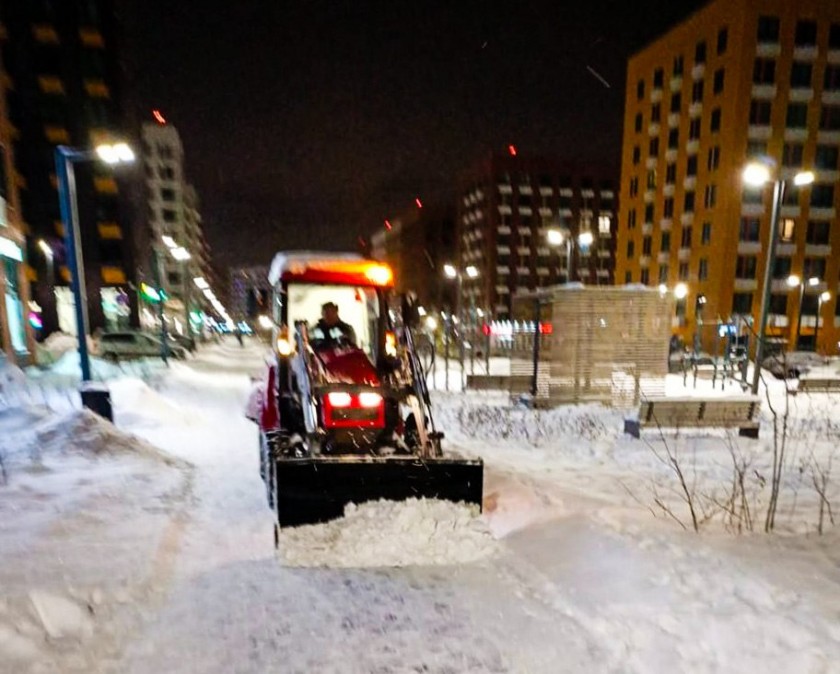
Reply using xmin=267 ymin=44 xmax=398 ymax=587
xmin=140 ymin=116 xmax=211 ymax=334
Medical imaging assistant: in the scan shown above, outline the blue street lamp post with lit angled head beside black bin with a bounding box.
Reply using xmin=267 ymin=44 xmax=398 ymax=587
xmin=55 ymin=143 xmax=134 ymax=386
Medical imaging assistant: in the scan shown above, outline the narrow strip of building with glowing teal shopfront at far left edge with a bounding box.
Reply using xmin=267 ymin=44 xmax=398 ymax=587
xmin=0 ymin=46 xmax=34 ymax=363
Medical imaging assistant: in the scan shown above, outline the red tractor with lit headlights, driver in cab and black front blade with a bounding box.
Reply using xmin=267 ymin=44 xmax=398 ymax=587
xmin=252 ymin=252 xmax=483 ymax=527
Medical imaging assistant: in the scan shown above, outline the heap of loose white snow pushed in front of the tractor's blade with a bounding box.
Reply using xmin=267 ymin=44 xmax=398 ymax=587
xmin=280 ymin=499 xmax=499 ymax=568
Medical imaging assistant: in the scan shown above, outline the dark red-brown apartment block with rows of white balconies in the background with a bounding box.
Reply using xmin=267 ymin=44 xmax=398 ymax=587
xmin=457 ymin=154 xmax=617 ymax=319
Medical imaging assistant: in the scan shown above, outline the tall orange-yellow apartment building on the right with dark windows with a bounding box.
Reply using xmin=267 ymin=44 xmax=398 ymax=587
xmin=616 ymin=0 xmax=840 ymax=353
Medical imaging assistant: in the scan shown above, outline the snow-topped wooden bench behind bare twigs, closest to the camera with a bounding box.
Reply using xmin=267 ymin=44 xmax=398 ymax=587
xmin=624 ymin=396 xmax=761 ymax=438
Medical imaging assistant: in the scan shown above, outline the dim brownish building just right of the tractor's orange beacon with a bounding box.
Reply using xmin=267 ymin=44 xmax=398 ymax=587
xmin=370 ymin=204 xmax=457 ymax=310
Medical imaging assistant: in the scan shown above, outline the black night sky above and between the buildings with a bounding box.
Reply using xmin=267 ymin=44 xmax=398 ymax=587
xmin=123 ymin=0 xmax=704 ymax=269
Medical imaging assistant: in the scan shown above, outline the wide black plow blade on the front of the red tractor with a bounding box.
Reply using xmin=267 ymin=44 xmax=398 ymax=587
xmin=275 ymin=456 xmax=484 ymax=528
